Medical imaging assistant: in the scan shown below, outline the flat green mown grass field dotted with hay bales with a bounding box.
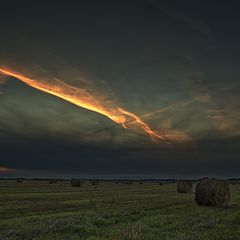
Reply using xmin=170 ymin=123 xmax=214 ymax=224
xmin=0 ymin=180 xmax=240 ymax=240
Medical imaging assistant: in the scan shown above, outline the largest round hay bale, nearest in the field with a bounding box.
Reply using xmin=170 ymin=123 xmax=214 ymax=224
xmin=195 ymin=178 xmax=230 ymax=207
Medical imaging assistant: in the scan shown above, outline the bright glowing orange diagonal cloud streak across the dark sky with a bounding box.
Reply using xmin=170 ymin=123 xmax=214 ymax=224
xmin=0 ymin=68 xmax=167 ymax=141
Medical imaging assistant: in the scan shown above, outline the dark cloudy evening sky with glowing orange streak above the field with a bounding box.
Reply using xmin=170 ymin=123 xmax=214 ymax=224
xmin=0 ymin=0 xmax=240 ymax=178
